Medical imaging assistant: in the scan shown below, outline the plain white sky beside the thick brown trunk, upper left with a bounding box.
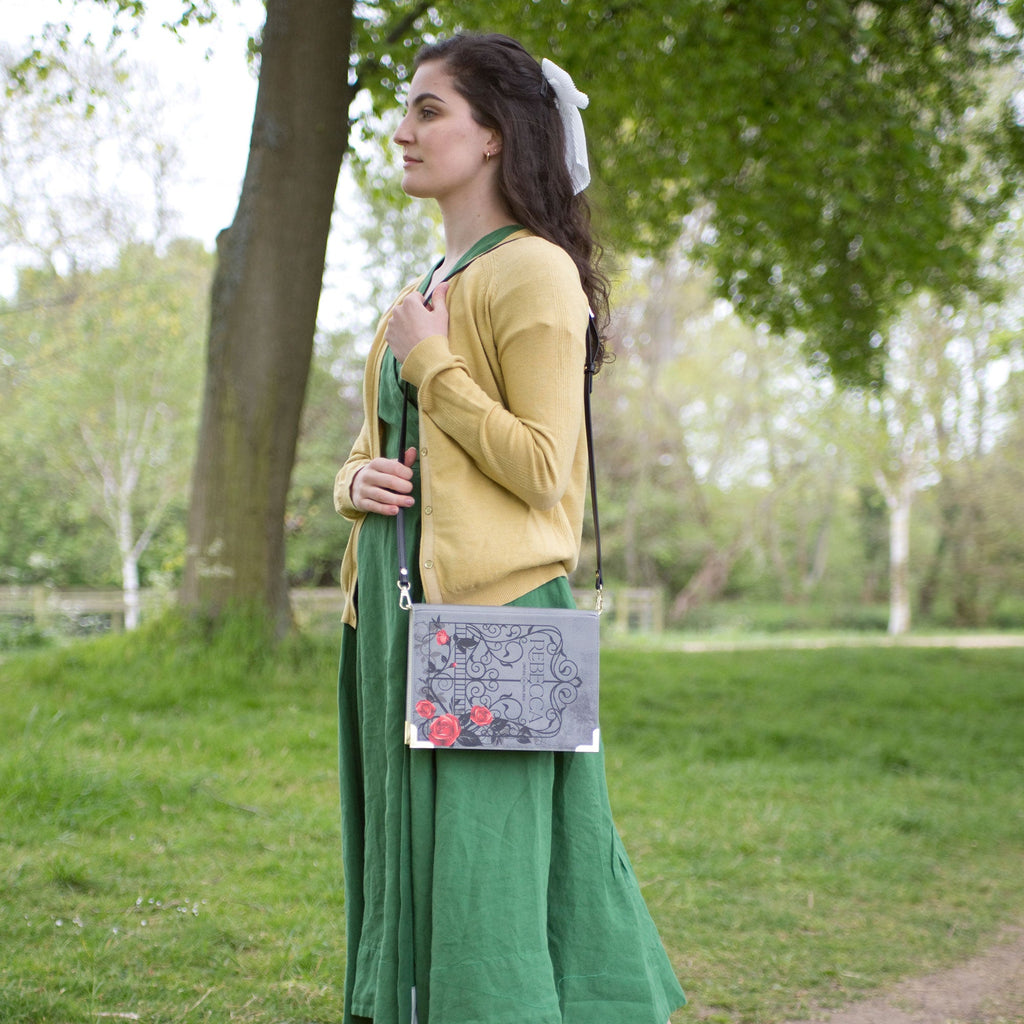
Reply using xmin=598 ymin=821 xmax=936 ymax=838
xmin=0 ymin=0 xmax=360 ymax=330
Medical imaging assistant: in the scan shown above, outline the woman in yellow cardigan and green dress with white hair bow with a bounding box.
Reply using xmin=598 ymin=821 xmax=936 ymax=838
xmin=335 ymin=36 xmax=684 ymax=1024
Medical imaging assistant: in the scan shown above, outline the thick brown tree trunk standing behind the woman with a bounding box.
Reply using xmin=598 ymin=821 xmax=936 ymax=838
xmin=180 ymin=0 xmax=352 ymax=633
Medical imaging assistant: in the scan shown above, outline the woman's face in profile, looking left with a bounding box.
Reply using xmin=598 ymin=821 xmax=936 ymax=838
xmin=394 ymin=60 xmax=501 ymax=205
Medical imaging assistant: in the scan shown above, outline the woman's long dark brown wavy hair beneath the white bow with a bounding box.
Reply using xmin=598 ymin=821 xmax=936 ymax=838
xmin=415 ymin=34 xmax=608 ymax=365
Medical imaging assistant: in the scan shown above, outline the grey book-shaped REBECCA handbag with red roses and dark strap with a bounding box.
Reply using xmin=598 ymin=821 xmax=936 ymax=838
xmin=397 ymin=319 xmax=604 ymax=751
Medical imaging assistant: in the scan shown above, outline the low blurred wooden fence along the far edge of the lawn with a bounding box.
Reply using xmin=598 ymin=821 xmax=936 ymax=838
xmin=0 ymin=586 xmax=665 ymax=633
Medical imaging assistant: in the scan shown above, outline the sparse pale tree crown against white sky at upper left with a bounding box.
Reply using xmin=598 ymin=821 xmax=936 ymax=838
xmin=0 ymin=47 xmax=178 ymax=274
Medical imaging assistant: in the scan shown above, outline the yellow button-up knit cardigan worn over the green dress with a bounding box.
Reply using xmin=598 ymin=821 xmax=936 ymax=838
xmin=334 ymin=230 xmax=589 ymax=626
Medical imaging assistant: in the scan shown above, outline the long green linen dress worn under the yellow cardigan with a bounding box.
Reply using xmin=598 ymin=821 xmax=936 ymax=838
xmin=339 ymin=258 xmax=685 ymax=1024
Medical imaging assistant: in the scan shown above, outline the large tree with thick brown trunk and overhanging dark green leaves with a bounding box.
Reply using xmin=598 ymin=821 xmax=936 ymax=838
xmin=9 ymin=0 xmax=1021 ymax=628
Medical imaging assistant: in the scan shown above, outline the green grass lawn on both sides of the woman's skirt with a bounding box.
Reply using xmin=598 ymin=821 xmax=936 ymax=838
xmin=0 ymin=620 xmax=1024 ymax=1024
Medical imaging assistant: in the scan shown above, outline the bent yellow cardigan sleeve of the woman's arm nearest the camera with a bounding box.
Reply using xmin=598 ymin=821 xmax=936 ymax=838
xmin=402 ymin=239 xmax=588 ymax=509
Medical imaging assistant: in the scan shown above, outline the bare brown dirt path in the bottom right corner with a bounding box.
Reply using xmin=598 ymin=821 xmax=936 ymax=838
xmin=791 ymin=927 xmax=1024 ymax=1024
